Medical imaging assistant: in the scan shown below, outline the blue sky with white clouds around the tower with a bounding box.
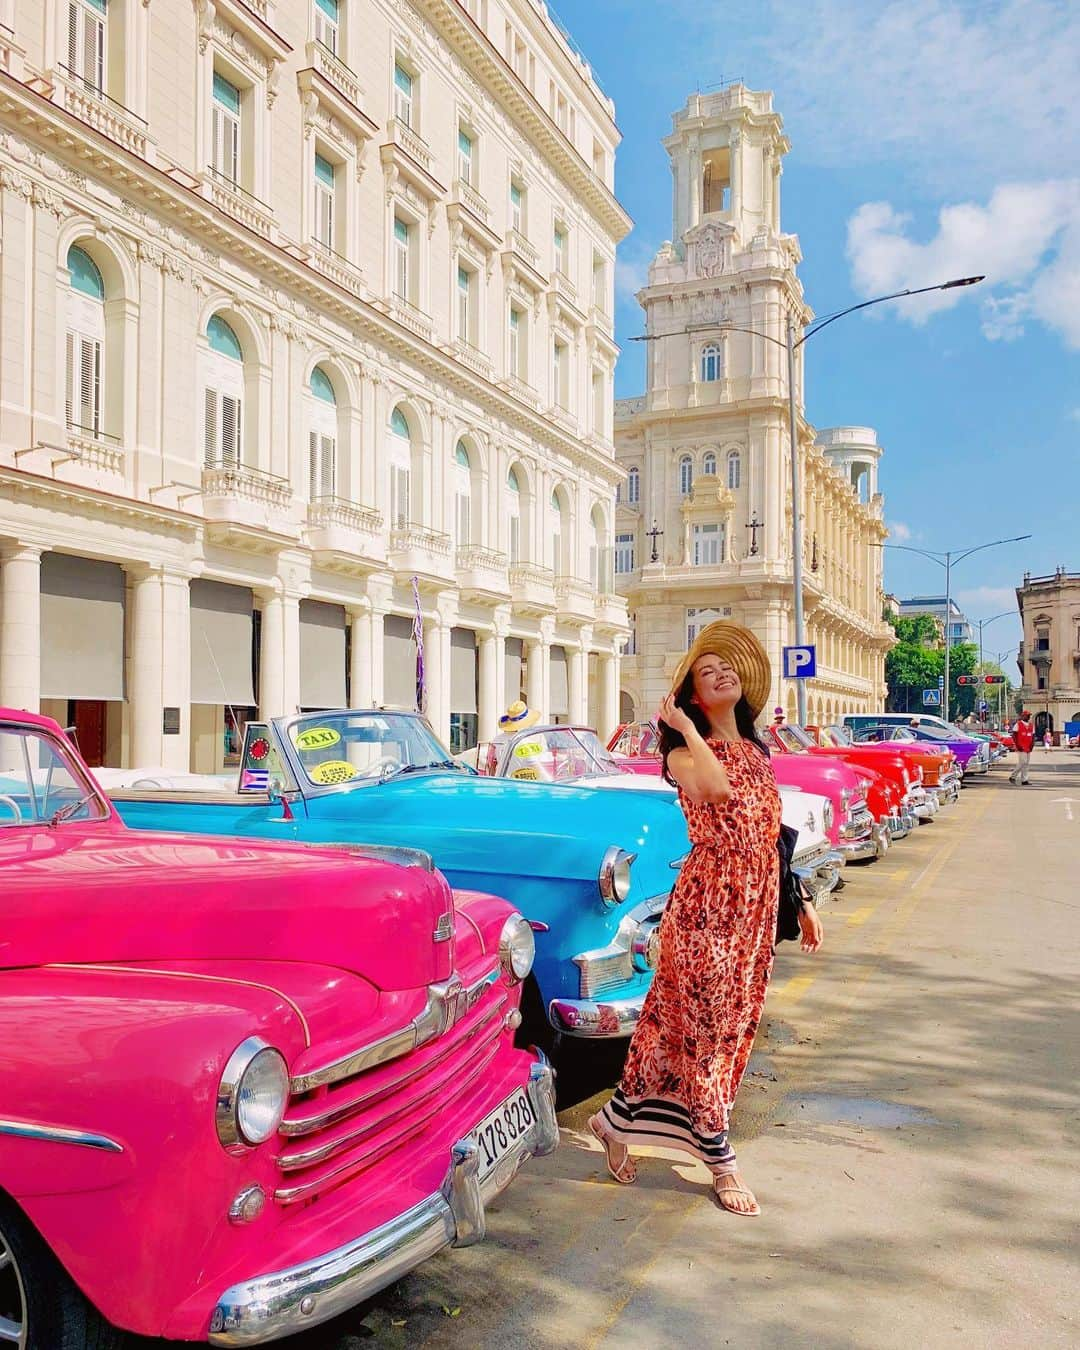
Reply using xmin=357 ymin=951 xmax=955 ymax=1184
xmin=554 ymin=0 xmax=1080 ymax=670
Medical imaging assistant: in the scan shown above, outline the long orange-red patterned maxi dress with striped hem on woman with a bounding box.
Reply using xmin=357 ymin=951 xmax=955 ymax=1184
xmin=602 ymin=740 xmax=780 ymax=1173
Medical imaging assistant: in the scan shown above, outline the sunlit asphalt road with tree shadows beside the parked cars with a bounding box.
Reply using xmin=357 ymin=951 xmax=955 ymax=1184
xmin=139 ymin=751 xmax=1080 ymax=1350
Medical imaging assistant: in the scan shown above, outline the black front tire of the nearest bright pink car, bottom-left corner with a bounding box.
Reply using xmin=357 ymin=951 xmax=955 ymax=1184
xmin=0 ymin=1197 xmax=123 ymax=1350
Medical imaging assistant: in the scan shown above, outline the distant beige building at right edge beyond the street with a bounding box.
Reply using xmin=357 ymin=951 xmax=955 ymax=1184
xmin=1017 ymin=567 xmax=1080 ymax=736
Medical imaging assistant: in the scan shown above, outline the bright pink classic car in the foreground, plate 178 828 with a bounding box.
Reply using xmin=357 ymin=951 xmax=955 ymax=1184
xmin=0 ymin=709 xmax=558 ymax=1350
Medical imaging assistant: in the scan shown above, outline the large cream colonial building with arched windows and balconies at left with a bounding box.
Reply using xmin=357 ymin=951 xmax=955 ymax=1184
xmin=0 ymin=0 xmax=629 ymax=770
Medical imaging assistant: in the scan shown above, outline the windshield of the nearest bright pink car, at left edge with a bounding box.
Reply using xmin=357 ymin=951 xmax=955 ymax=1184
xmin=0 ymin=722 xmax=108 ymax=829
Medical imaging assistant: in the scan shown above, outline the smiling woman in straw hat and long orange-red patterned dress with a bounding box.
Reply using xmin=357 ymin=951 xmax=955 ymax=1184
xmin=589 ymin=621 xmax=822 ymax=1216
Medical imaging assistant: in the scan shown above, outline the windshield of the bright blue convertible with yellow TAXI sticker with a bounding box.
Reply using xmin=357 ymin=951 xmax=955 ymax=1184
xmin=278 ymin=711 xmax=459 ymax=787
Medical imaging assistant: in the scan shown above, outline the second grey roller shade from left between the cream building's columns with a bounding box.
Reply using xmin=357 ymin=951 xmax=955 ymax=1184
xmin=190 ymin=576 xmax=255 ymax=707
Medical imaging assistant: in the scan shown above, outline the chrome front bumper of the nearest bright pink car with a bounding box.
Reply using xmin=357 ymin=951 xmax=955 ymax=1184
xmin=208 ymin=1050 xmax=559 ymax=1346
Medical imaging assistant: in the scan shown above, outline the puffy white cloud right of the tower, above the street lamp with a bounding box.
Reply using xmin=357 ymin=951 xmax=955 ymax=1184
xmin=848 ymin=178 xmax=1080 ymax=348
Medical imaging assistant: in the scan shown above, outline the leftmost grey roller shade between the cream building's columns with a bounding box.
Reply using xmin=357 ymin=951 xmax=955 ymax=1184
xmin=41 ymin=554 xmax=124 ymax=702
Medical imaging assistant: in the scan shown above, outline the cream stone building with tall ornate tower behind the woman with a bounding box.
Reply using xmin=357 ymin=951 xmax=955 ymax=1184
xmin=614 ymin=84 xmax=892 ymax=721
